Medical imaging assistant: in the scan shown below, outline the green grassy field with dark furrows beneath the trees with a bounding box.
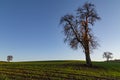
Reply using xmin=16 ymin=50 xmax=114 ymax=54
xmin=0 ymin=61 xmax=120 ymax=80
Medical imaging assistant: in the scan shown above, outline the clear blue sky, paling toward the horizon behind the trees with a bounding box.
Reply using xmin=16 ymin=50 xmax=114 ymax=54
xmin=0 ymin=0 xmax=120 ymax=61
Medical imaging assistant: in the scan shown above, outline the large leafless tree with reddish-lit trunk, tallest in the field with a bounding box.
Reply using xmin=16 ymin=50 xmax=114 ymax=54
xmin=60 ymin=2 xmax=100 ymax=66
